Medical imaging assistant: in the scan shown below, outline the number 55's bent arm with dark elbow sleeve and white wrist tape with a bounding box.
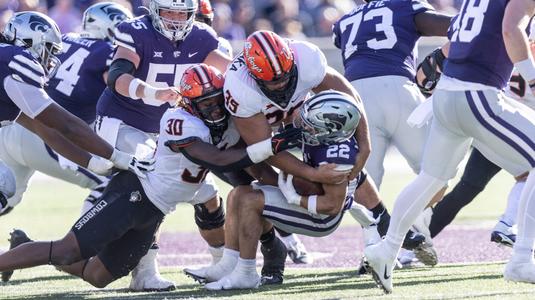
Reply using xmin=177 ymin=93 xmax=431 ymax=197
xmin=106 ymin=46 xmax=180 ymax=103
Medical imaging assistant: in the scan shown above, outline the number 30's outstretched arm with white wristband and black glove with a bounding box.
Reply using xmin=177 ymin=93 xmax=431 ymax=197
xmin=165 ymin=128 xmax=301 ymax=172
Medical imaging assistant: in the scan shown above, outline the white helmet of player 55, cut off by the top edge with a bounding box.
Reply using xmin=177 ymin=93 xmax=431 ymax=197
xmin=149 ymin=0 xmax=198 ymax=42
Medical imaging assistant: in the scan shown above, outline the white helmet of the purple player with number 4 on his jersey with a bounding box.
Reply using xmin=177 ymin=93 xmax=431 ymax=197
xmin=81 ymin=2 xmax=133 ymax=42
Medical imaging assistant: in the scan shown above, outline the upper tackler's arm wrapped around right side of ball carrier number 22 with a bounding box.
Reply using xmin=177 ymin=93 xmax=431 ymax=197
xmin=313 ymin=67 xmax=371 ymax=179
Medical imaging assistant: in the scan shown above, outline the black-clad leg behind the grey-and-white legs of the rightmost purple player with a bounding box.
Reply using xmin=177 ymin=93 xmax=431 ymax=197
xmin=429 ymin=149 xmax=501 ymax=237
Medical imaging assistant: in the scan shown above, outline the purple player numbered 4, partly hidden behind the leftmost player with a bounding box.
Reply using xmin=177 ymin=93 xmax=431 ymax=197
xmin=0 ymin=2 xmax=131 ymax=220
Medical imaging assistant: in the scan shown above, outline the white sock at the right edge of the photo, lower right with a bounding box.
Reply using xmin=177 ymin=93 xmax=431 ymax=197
xmin=512 ymin=169 xmax=535 ymax=262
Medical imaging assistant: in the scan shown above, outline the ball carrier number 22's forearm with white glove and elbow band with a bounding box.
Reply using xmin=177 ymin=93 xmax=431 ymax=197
xmin=279 ymin=171 xmax=352 ymax=216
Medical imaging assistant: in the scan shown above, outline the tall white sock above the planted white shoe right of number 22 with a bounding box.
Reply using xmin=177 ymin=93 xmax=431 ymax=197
xmin=385 ymin=172 xmax=446 ymax=258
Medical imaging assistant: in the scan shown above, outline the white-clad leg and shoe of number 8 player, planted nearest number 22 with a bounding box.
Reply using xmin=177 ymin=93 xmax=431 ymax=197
xmin=364 ymin=90 xmax=471 ymax=292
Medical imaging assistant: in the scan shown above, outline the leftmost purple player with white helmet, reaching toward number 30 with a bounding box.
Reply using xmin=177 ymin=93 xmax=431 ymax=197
xmin=0 ymin=12 xmax=152 ymax=211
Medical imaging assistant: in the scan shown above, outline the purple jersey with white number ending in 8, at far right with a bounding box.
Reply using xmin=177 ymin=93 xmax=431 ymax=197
xmin=444 ymin=0 xmax=513 ymax=89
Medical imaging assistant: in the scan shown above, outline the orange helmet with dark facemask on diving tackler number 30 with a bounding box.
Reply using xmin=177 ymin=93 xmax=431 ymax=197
xmin=180 ymin=64 xmax=229 ymax=140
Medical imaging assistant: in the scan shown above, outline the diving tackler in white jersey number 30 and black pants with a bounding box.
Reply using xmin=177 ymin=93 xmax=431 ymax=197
xmin=0 ymin=65 xmax=301 ymax=288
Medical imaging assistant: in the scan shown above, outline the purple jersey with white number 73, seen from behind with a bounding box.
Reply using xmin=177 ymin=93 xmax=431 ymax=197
xmin=333 ymin=0 xmax=433 ymax=81
